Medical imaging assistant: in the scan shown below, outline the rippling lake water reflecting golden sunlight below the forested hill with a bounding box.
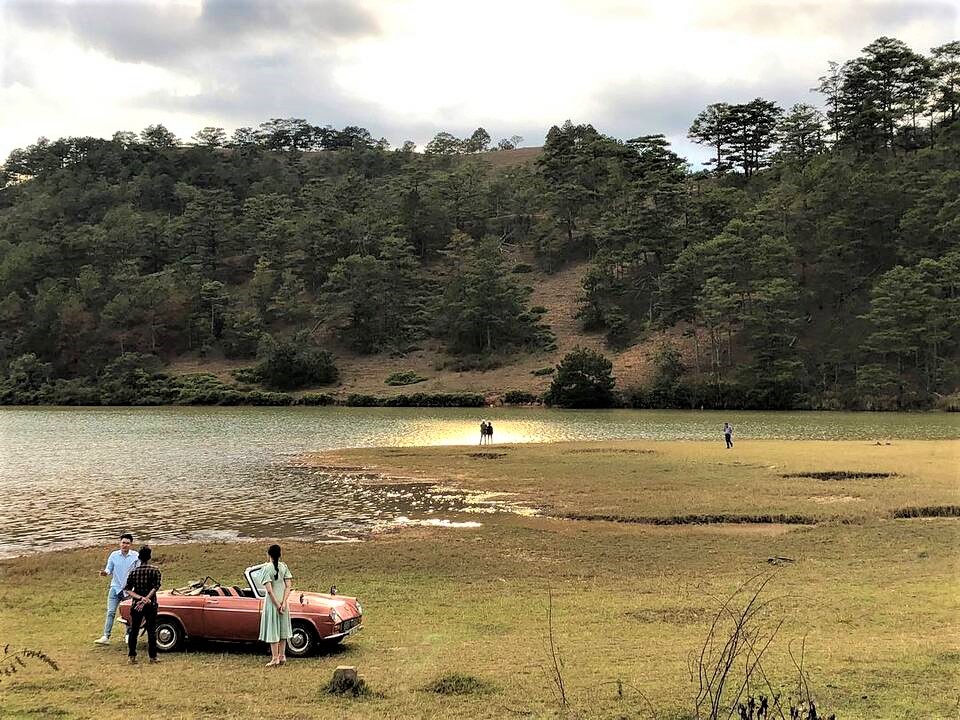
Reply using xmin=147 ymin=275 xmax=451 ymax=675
xmin=0 ymin=407 xmax=960 ymax=557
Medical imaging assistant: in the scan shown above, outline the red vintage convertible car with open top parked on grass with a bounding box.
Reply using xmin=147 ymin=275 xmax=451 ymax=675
xmin=120 ymin=565 xmax=363 ymax=657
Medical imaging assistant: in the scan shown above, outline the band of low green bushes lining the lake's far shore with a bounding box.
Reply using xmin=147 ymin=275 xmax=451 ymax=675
xmin=0 ymin=346 xmax=960 ymax=412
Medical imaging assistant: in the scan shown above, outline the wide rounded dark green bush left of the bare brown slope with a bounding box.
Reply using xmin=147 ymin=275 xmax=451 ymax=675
xmin=257 ymin=332 xmax=338 ymax=390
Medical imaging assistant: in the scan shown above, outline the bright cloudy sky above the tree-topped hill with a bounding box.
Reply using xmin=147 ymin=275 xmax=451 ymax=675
xmin=0 ymin=0 xmax=960 ymax=160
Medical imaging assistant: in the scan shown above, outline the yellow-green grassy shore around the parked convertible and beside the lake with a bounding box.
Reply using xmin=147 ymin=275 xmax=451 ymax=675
xmin=0 ymin=441 xmax=960 ymax=720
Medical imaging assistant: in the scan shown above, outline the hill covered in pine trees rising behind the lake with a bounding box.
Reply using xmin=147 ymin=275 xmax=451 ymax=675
xmin=0 ymin=38 xmax=960 ymax=409
